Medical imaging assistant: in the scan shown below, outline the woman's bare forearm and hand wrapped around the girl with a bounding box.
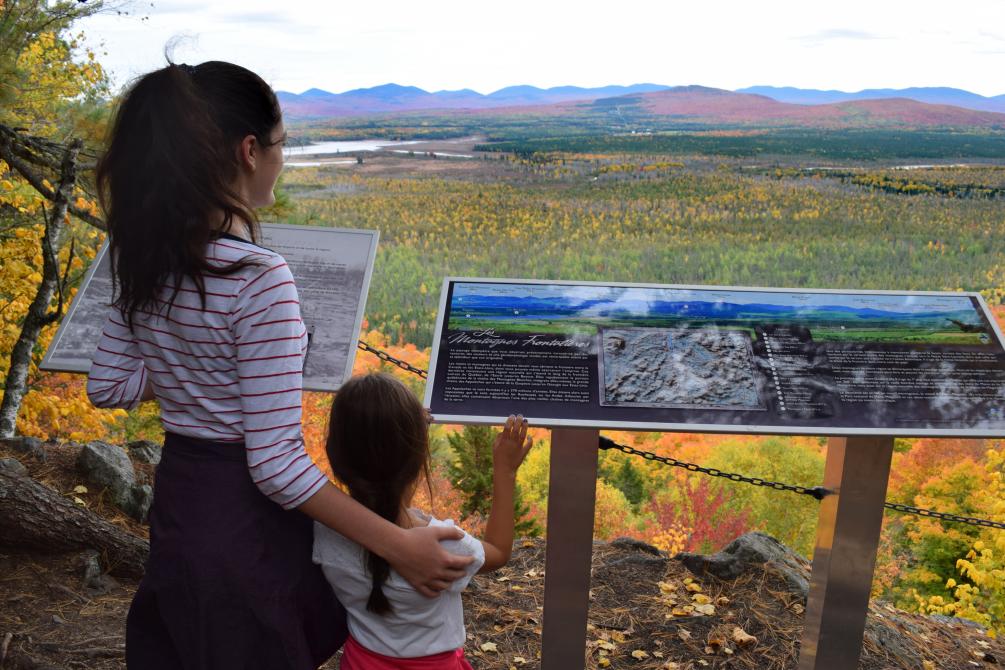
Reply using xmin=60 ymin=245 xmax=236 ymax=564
xmin=297 ymin=483 xmax=474 ymax=598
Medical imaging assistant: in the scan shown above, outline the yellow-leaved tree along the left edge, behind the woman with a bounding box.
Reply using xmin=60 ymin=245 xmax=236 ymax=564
xmin=0 ymin=0 xmax=124 ymax=439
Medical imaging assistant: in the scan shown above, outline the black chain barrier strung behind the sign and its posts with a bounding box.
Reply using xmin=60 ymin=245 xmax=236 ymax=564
xmin=359 ymin=341 xmax=1005 ymax=530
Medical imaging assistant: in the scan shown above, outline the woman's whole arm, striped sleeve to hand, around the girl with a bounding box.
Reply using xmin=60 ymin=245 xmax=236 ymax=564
xmin=231 ymin=256 xmax=470 ymax=597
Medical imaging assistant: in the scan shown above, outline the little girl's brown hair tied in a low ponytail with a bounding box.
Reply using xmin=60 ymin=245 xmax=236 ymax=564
xmin=327 ymin=374 xmax=429 ymax=614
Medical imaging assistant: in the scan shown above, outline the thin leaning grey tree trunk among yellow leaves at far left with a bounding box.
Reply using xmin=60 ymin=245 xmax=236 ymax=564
xmin=0 ymin=140 xmax=82 ymax=439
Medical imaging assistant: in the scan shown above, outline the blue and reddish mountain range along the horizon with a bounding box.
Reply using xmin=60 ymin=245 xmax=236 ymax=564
xmin=277 ymin=83 xmax=1005 ymax=125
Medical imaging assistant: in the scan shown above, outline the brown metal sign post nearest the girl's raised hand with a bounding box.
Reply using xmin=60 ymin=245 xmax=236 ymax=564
xmin=541 ymin=428 xmax=600 ymax=670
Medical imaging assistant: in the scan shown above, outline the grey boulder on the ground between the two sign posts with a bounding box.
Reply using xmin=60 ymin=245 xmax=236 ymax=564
xmin=674 ymin=531 xmax=810 ymax=600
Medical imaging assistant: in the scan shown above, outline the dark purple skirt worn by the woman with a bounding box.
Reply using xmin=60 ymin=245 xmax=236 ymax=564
xmin=126 ymin=433 xmax=347 ymax=670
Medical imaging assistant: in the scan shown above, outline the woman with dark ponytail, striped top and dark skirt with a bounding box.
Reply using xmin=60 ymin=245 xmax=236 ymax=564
xmin=87 ymin=61 xmax=470 ymax=670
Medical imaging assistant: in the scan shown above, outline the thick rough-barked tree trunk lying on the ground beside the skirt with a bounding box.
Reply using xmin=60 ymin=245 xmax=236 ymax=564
xmin=0 ymin=472 xmax=150 ymax=577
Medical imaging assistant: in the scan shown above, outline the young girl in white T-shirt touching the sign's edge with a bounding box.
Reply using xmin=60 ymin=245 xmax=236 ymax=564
xmin=314 ymin=375 xmax=531 ymax=670
